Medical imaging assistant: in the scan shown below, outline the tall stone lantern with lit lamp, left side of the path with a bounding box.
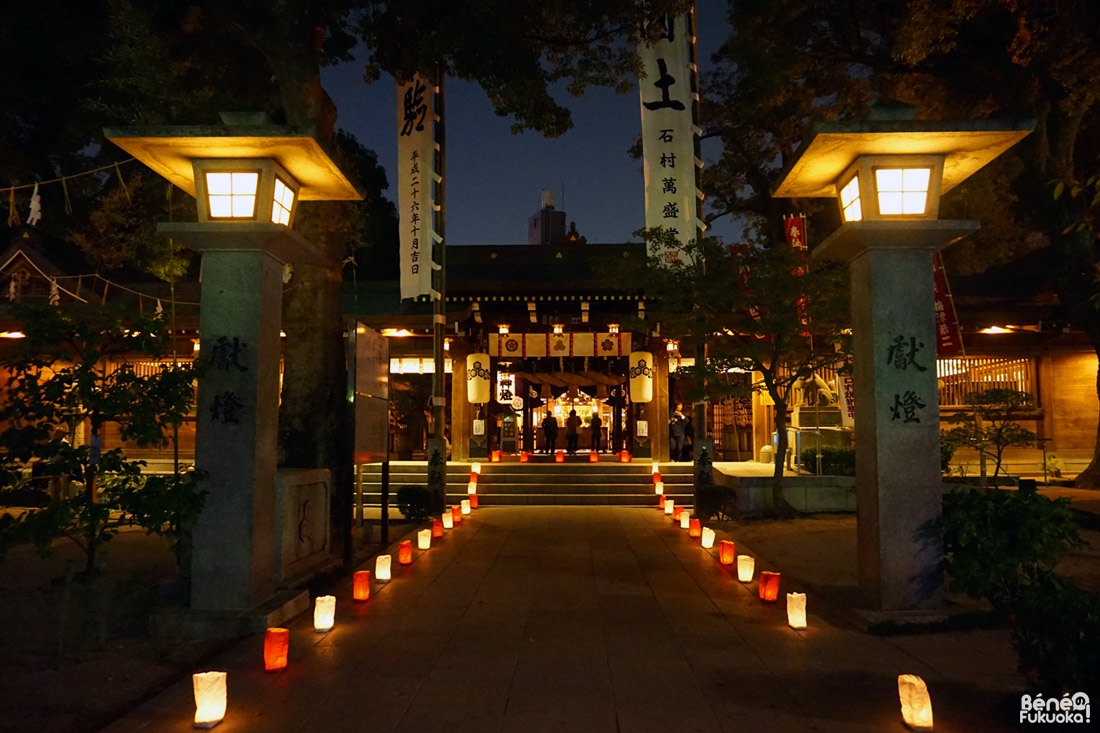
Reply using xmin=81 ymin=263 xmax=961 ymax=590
xmin=105 ymin=125 xmax=361 ymax=612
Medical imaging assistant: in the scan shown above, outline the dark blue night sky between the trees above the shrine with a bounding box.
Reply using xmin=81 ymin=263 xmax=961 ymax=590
xmin=323 ymin=0 xmax=733 ymax=244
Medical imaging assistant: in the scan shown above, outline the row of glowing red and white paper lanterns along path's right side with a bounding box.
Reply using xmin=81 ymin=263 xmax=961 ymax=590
xmin=652 ymin=463 xmax=933 ymax=731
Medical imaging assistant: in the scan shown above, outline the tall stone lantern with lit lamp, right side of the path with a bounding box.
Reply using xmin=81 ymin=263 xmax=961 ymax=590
xmin=773 ymin=107 xmax=1033 ymax=611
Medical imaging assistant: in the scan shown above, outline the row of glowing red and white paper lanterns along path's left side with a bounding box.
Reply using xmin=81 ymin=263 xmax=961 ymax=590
xmin=191 ymin=463 xmax=481 ymax=729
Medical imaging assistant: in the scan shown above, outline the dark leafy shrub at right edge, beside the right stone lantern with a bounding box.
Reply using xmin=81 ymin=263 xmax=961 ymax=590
xmin=943 ymin=488 xmax=1100 ymax=693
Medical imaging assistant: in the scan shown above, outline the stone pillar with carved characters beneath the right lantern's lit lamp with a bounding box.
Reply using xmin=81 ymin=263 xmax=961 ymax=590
xmin=814 ymin=220 xmax=977 ymax=611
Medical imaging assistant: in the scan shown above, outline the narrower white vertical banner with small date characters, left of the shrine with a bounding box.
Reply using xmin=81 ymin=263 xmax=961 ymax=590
xmin=397 ymin=75 xmax=437 ymax=299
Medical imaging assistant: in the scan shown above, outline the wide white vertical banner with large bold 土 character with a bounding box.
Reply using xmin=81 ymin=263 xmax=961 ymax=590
xmin=638 ymin=15 xmax=701 ymax=264
